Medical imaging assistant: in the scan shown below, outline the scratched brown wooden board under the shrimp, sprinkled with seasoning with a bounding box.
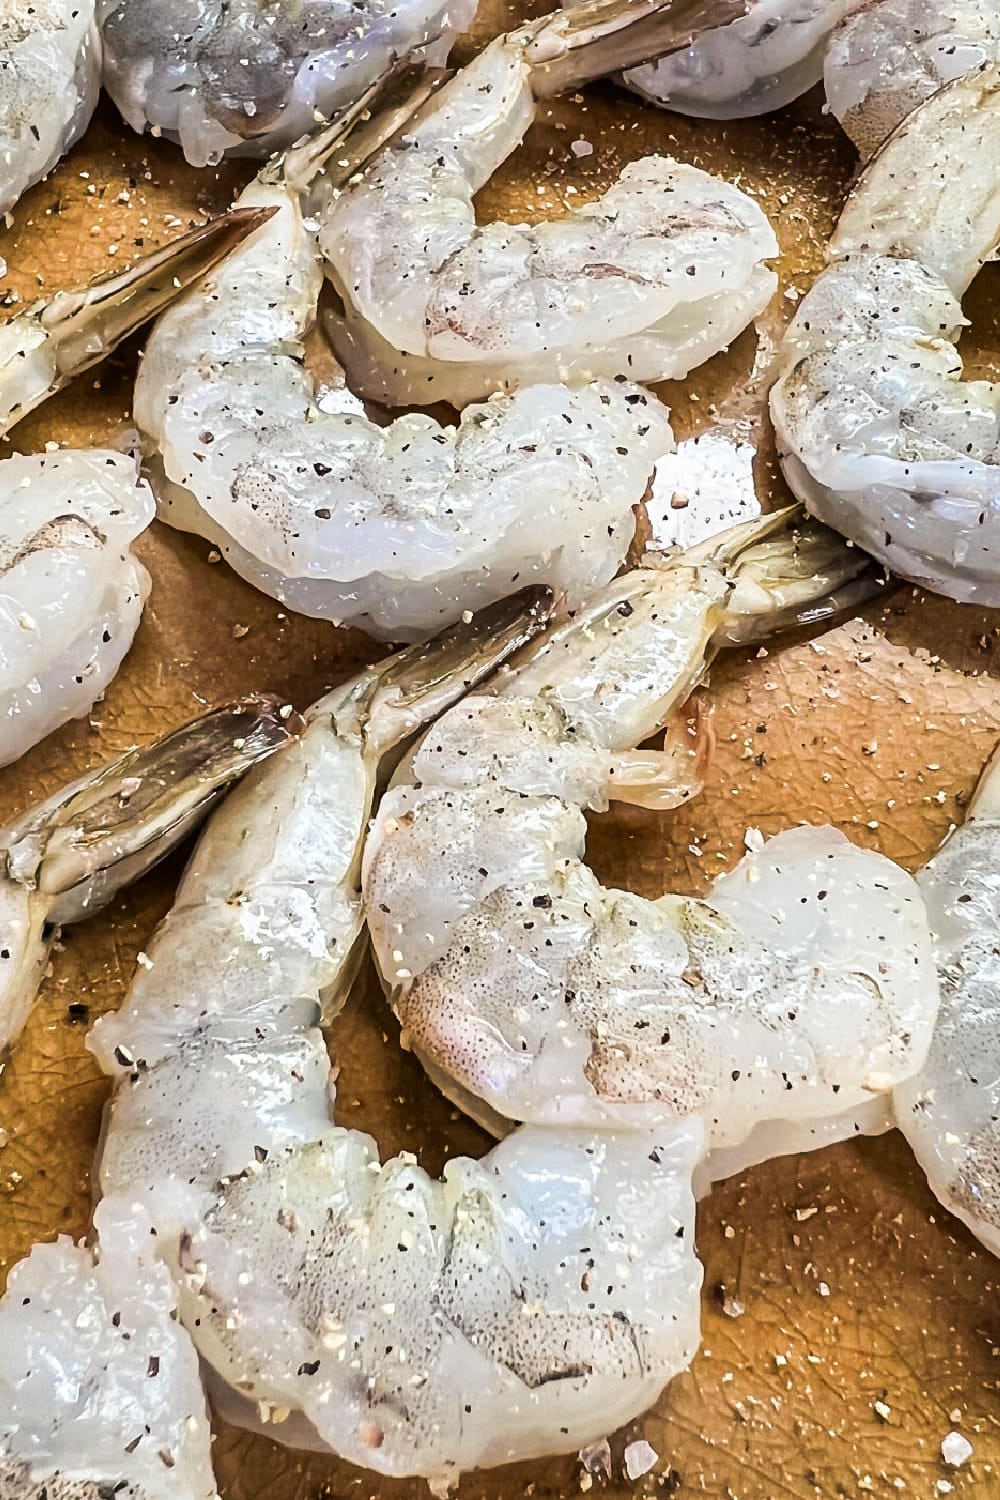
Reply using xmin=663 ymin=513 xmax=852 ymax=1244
xmin=0 ymin=0 xmax=1000 ymax=1500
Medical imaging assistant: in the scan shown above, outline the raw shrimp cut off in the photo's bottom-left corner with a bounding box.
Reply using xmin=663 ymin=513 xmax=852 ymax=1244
xmin=0 ymin=1199 xmax=217 ymax=1500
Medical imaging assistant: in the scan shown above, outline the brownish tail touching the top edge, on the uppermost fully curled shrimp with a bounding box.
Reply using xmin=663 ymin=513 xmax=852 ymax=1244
xmin=525 ymin=0 xmax=750 ymax=98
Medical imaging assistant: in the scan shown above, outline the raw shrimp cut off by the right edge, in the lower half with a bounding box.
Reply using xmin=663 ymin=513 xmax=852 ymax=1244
xmin=895 ymin=750 xmax=1000 ymax=1256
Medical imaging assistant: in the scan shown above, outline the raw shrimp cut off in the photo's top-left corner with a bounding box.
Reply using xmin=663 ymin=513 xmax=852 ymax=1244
xmin=0 ymin=0 xmax=100 ymax=215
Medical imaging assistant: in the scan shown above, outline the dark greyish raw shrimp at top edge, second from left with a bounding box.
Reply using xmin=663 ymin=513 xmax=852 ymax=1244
xmin=97 ymin=0 xmax=477 ymax=167
